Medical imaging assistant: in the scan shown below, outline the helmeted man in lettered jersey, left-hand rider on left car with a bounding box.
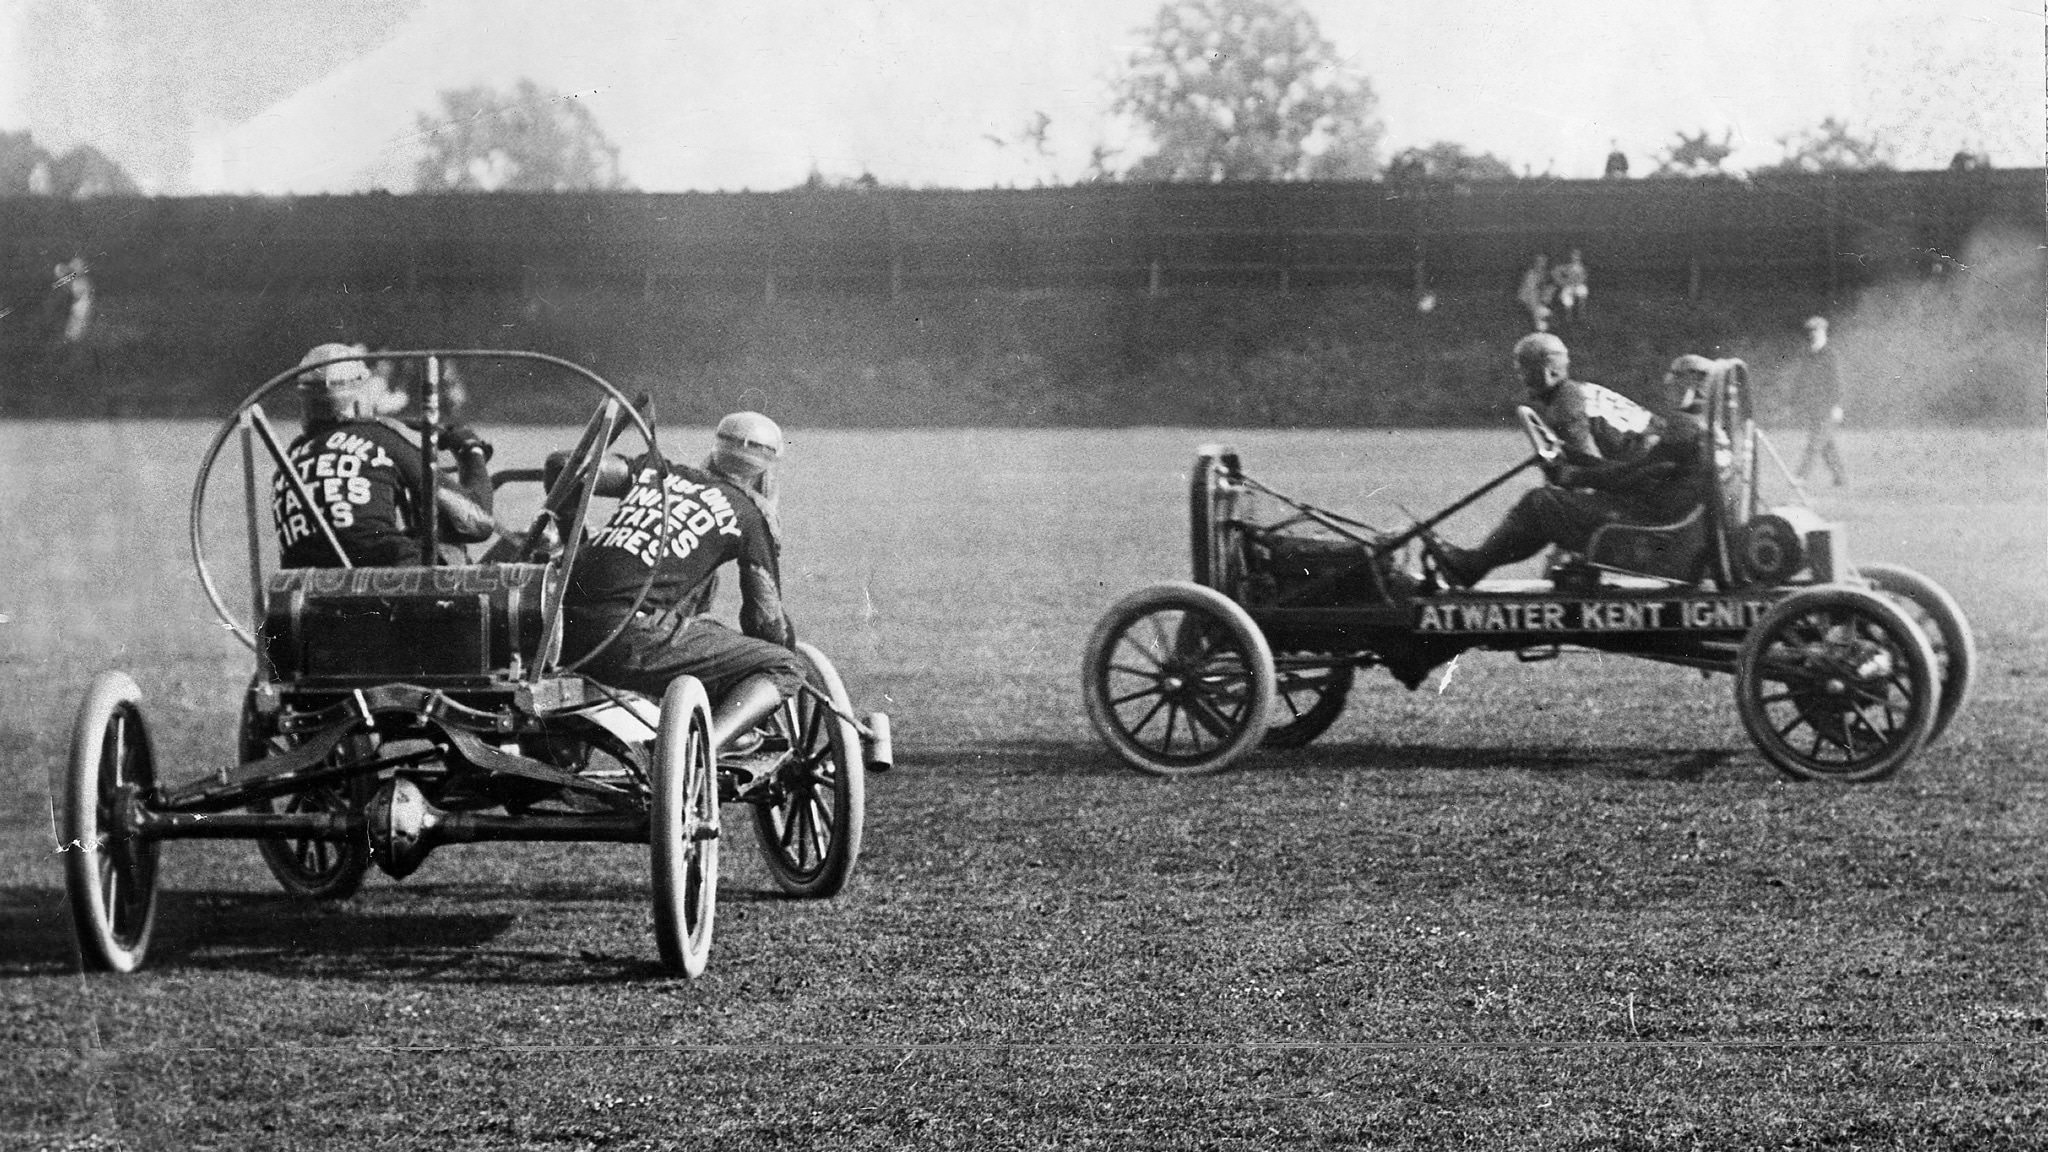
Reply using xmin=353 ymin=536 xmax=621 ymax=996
xmin=270 ymin=344 xmax=498 ymax=568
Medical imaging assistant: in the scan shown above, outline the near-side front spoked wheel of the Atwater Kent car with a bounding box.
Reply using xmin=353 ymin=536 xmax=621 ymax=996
xmin=1081 ymin=582 xmax=1276 ymax=777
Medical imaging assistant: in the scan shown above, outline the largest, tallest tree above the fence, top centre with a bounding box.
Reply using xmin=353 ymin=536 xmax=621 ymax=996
xmin=1114 ymin=0 xmax=1384 ymax=182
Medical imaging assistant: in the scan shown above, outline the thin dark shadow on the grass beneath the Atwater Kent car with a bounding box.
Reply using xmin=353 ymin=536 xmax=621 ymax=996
xmin=913 ymin=740 xmax=1743 ymax=783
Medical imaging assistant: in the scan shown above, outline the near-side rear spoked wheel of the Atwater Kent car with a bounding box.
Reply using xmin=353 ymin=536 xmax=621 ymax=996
xmin=1735 ymin=586 xmax=1942 ymax=783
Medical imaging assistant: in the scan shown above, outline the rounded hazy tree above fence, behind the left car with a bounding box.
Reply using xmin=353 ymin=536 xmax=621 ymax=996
xmin=414 ymin=80 xmax=627 ymax=193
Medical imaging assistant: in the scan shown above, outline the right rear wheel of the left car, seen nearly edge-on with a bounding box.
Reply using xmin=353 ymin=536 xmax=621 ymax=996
xmin=649 ymin=676 xmax=719 ymax=978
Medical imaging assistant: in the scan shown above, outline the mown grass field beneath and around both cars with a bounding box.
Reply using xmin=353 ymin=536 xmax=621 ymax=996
xmin=0 ymin=424 xmax=2048 ymax=1150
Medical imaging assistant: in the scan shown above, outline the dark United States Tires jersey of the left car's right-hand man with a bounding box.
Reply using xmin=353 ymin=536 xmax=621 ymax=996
xmin=567 ymin=455 xmax=780 ymax=619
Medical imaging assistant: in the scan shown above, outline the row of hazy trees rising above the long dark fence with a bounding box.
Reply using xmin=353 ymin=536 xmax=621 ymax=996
xmin=0 ymin=0 xmax=1982 ymax=199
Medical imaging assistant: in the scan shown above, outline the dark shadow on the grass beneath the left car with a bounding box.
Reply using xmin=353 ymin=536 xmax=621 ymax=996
xmin=0 ymin=883 xmax=782 ymax=986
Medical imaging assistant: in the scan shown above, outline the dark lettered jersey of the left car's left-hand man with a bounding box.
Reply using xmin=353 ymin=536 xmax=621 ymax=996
xmin=270 ymin=420 xmax=426 ymax=568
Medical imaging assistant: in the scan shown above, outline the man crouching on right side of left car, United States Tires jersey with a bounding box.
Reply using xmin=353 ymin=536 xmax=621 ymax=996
xmin=549 ymin=407 xmax=803 ymax=766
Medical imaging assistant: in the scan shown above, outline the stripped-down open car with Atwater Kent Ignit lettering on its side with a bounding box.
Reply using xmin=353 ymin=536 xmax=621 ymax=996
xmin=1081 ymin=361 xmax=1974 ymax=781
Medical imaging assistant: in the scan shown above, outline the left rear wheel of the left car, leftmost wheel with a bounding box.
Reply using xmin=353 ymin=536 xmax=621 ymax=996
xmin=63 ymin=672 xmax=160 ymax=972
